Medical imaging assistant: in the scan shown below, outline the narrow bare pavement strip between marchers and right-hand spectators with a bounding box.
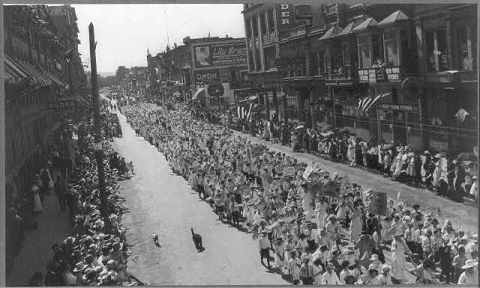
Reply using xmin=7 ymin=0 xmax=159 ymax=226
xmin=232 ymin=130 xmax=478 ymax=233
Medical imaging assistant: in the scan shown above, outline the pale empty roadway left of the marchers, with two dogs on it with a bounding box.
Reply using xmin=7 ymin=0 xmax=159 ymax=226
xmin=114 ymin=116 xmax=286 ymax=285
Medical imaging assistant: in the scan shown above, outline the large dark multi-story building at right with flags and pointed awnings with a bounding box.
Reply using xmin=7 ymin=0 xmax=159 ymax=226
xmin=243 ymin=3 xmax=478 ymax=152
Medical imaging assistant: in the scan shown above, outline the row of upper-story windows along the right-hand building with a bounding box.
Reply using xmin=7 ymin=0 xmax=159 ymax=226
xmin=249 ymin=18 xmax=476 ymax=78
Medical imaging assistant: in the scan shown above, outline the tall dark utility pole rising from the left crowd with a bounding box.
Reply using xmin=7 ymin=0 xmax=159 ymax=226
xmin=88 ymin=23 xmax=108 ymax=219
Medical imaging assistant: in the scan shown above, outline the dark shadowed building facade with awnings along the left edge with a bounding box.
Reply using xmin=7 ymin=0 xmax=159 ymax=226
xmin=3 ymin=5 xmax=86 ymax=274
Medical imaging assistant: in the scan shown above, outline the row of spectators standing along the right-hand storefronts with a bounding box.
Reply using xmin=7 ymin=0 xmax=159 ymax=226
xmin=230 ymin=117 xmax=478 ymax=203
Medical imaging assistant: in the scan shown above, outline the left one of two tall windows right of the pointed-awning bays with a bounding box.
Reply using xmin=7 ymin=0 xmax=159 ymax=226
xmin=425 ymin=28 xmax=449 ymax=72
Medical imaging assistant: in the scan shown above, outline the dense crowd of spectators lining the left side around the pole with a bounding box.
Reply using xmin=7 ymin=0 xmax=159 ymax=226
xmin=12 ymin=112 xmax=141 ymax=286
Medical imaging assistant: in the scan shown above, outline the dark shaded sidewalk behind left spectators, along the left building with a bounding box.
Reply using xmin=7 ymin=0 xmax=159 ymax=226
xmin=6 ymin=191 xmax=71 ymax=286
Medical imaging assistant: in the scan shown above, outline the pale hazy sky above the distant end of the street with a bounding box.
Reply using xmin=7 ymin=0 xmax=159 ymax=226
xmin=76 ymin=4 xmax=245 ymax=73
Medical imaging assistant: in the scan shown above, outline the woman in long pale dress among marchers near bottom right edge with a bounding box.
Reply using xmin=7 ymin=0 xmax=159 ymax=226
xmin=387 ymin=233 xmax=416 ymax=284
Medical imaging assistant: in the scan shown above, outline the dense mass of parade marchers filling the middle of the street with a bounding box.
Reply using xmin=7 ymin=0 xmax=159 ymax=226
xmin=121 ymin=104 xmax=478 ymax=285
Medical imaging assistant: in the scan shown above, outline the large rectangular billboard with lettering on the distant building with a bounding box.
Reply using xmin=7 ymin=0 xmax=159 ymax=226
xmin=194 ymin=42 xmax=247 ymax=68
